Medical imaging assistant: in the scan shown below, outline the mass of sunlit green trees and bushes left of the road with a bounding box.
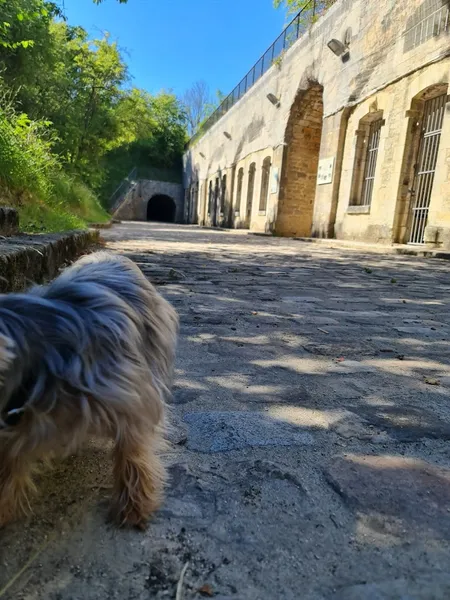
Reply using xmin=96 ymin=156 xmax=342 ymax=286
xmin=0 ymin=0 xmax=186 ymax=229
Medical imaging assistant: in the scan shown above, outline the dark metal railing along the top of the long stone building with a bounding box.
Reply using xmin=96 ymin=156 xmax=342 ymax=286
xmin=188 ymin=0 xmax=337 ymax=145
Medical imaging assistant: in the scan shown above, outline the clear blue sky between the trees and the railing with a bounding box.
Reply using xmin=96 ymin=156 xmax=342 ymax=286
xmin=61 ymin=0 xmax=285 ymax=94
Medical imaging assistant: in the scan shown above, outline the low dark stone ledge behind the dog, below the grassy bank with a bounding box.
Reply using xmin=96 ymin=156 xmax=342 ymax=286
xmin=0 ymin=231 xmax=99 ymax=293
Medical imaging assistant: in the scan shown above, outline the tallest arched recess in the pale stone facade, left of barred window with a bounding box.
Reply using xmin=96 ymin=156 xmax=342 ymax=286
xmin=275 ymin=84 xmax=323 ymax=237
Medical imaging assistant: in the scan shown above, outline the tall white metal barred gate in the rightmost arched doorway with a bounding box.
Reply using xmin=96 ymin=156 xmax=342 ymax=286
xmin=409 ymin=94 xmax=447 ymax=244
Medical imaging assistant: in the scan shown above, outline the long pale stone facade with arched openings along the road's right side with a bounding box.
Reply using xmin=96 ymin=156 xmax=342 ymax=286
xmin=184 ymin=0 xmax=450 ymax=248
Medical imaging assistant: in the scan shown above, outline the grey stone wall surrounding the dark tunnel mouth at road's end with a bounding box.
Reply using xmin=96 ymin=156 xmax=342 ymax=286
xmin=114 ymin=179 xmax=184 ymax=223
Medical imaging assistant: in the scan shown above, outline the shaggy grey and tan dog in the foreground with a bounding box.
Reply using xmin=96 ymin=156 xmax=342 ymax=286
xmin=0 ymin=252 xmax=178 ymax=527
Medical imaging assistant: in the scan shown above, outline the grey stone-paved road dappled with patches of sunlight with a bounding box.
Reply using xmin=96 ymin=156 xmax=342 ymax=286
xmin=0 ymin=223 xmax=450 ymax=600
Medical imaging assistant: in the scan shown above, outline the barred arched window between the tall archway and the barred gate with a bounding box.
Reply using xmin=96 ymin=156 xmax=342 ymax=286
xmin=350 ymin=111 xmax=384 ymax=207
